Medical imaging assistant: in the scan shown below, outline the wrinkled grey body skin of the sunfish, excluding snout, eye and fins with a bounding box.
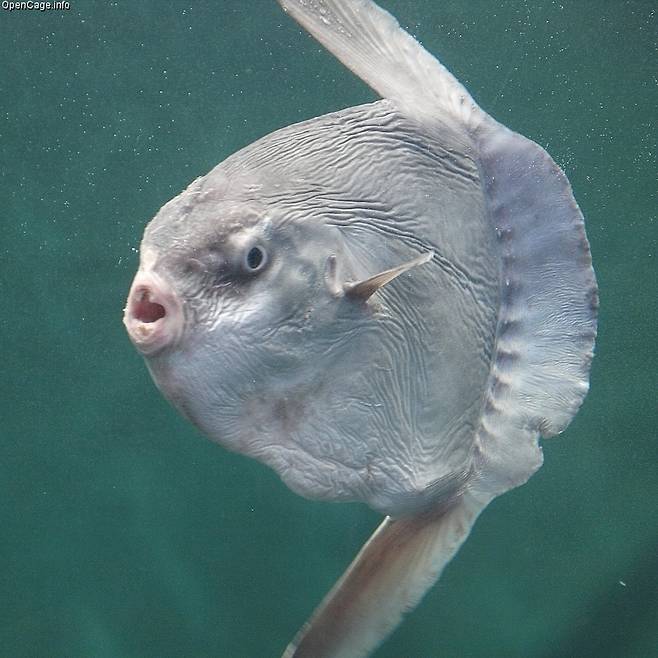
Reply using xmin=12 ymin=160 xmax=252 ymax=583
xmin=141 ymin=100 xmax=500 ymax=515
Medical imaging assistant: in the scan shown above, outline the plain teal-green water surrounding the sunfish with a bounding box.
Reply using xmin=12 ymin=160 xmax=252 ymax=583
xmin=0 ymin=0 xmax=658 ymax=658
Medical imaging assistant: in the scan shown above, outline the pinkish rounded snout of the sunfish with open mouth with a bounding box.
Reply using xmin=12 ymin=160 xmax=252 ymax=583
xmin=123 ymin=271 xmax=183 ymax=356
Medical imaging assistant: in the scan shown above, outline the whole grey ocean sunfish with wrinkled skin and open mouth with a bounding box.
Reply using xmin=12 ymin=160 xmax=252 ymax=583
xmin=124 ymin=0 xmax=598 ymax=658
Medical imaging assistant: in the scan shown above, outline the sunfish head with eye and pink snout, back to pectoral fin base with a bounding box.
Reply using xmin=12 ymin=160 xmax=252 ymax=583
xmin=124 ymin=171 xmax=358 ymax=456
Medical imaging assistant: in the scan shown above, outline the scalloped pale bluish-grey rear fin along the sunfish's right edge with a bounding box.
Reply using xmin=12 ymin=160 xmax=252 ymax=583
xmin=471 ymin=117 xmax=598 ymax=495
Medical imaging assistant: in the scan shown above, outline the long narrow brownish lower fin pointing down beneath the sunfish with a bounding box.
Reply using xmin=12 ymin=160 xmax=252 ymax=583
xmin=283 ymin=493 xmax=486 ymax=658
